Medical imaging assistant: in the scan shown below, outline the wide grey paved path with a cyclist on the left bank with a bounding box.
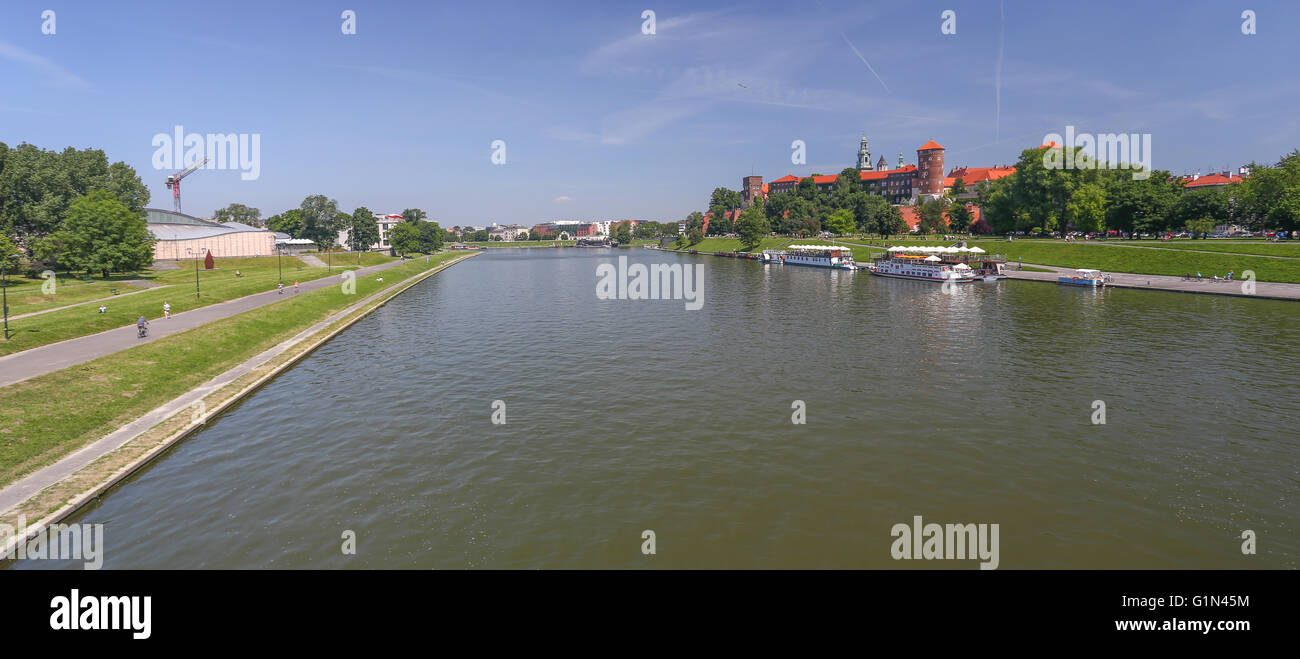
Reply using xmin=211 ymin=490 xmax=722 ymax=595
xmin=0 ymin=260 xmax=406 ymax=386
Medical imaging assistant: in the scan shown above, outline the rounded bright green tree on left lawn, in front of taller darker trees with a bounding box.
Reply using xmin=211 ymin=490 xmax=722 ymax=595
xmin=60 ymin=190 xmax=153 ymax=279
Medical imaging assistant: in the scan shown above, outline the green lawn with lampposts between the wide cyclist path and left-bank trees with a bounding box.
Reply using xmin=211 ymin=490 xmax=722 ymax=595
xmin=0 ymin=255 xmax=394 ymax=355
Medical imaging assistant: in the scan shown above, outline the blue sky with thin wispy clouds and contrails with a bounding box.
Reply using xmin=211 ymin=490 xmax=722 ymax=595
xmin=0 ymin=0 xmax=1300 ymax=225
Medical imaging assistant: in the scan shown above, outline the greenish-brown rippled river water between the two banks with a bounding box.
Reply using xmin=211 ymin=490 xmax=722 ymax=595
xmin=7 ymin=248 xmax=1300 ymax=569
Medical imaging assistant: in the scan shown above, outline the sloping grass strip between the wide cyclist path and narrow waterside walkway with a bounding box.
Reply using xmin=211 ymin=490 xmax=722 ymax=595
xmin=0 ymin=253 xmax=468 ymax=485
